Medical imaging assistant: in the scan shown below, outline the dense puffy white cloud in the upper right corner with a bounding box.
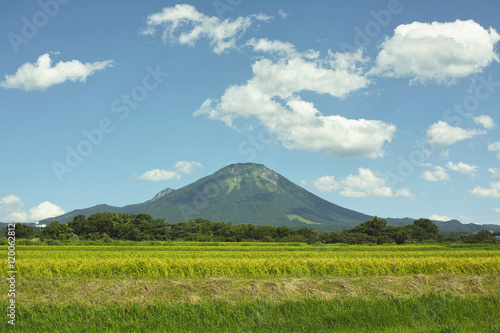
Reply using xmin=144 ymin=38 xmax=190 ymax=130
xmin=371 ymin=20 xmax=500 ymax=84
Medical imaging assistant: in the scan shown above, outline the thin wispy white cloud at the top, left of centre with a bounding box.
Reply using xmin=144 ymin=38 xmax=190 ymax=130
xmin=142 ymin=4 xmax=271 ymax=54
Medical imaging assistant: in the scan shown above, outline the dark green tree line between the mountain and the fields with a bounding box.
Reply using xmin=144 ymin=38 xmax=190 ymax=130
xmin=2 ymin=213 xmax=500 ymax=244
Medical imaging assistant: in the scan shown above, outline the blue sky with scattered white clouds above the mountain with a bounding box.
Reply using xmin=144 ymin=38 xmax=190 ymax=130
xmin=0 ymin=0 xmax=500 ymax=224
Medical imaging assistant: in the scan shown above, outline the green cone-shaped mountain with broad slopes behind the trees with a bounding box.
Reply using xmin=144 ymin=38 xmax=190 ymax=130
xmin=41 ymin=163 xmax=500 ymax=231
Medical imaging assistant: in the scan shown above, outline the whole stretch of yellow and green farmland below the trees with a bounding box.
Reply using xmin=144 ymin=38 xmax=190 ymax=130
xmin=2 ymin=242 xmax=500 ymax=332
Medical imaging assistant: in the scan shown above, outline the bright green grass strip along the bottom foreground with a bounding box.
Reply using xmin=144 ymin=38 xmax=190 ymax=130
xmin=2 ymin=294 xmax=500 ymax=333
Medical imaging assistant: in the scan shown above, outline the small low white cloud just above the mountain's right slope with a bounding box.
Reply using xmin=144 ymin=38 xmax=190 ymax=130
xmin=313 ymin=168 xmax=415 ymax=199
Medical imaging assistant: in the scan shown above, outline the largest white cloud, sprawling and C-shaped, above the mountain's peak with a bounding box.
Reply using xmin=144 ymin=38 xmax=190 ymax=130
xmin=194 ymin=49 xmax=396 ymax=158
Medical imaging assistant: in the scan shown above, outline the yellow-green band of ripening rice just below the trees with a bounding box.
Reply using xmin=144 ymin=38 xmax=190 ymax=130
xmin=10 ymin=244 xmax=500 ymax=278
